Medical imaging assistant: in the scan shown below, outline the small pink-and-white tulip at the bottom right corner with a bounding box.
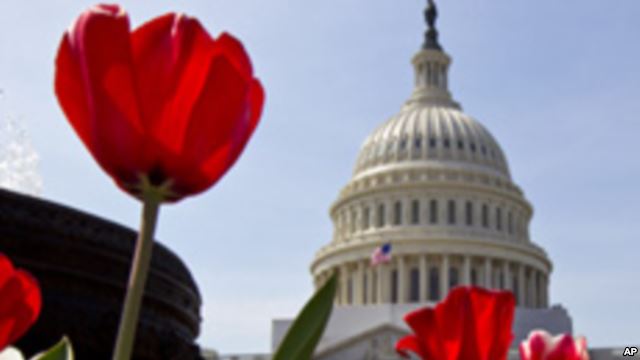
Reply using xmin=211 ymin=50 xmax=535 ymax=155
xmin=520 ymin=330 xmax=589 ymax=360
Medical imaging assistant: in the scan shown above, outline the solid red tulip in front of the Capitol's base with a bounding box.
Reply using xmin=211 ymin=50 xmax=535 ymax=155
xmin=396 ymin=287 xmax=515 ymax=360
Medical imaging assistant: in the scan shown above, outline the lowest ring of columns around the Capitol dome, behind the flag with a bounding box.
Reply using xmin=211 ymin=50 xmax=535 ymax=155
xmin=315 ymin=254 xmax=548 ymax=308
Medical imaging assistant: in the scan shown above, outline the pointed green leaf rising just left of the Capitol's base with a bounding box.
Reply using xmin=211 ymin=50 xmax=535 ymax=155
xmin=272 ymin=274 xmax=338 ymax=360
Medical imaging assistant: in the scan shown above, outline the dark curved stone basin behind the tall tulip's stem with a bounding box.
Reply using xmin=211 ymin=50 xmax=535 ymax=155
xmin=0 ymin=190 xmax=201 ymax=360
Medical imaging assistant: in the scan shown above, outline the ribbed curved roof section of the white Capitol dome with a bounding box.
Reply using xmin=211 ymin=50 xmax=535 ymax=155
xmin=354 ymin=102 xmax=510 ymax=179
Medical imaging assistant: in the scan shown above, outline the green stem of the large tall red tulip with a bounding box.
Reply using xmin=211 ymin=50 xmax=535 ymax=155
xmin=113 ymin=191 xmax=161 ymax=360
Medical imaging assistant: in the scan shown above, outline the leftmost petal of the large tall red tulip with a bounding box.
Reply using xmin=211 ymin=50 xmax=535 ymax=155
xmin=55 ymin=6 xmax=142 ymax=187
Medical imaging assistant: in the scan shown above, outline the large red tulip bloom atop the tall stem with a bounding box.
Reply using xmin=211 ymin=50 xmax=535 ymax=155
xmin=55 ymin=5 xmax=264 ymax=201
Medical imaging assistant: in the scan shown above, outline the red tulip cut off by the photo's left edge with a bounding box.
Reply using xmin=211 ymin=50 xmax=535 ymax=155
xmin=0 ymin=254 xmax=42 ymax=352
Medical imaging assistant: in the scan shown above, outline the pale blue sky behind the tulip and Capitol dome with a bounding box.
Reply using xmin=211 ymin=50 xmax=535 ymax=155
xmin=0 ymin=0 xmax=640 ymax=352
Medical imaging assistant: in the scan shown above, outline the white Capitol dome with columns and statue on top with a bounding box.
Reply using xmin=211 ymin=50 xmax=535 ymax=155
xmin=311 ymin=0 xmax=552 ymax=308
